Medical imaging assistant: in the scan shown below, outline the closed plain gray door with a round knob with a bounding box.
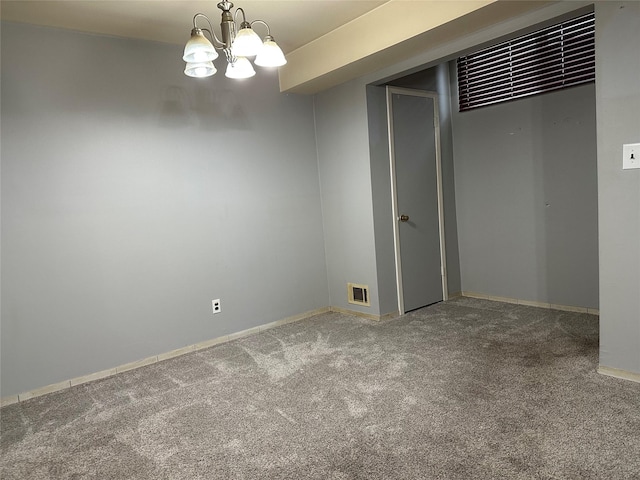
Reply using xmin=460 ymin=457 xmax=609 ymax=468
xmin=388 ymin=88 xmax=446 ymax=312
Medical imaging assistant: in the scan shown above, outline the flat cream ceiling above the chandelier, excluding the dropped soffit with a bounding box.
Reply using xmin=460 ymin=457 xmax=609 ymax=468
xmin=0 ymin=0 xmax=387 ymax=54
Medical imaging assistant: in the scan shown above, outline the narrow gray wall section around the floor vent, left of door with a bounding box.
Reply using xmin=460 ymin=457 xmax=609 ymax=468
xmin=315 ymin=81 xmax=388 ymax=315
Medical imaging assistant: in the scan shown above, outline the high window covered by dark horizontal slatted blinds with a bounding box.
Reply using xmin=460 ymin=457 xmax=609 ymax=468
xmin=457 ymin=13 xmax=595 ymax=111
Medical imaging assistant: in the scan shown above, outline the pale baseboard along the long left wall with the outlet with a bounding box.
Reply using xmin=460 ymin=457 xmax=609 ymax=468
xmin=0 ymin=307 xmax=332 ymax=407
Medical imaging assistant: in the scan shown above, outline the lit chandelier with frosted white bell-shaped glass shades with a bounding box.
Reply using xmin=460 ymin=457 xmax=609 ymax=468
xmin=182 ymin=0 xmax=287 ymax=78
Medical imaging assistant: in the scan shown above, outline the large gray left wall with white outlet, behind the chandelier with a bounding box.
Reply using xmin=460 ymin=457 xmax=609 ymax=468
xmin=1 ymin=23 xmax=330 ymax=396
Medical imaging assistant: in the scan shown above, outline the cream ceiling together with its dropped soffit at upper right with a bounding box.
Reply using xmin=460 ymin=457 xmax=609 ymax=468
xmin=0 ymin=0 xmax=568 ymax=94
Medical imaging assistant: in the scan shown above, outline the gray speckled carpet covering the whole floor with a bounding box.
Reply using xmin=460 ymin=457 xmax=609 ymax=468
xmin=0 ymin=298 xmax=640 ymax=480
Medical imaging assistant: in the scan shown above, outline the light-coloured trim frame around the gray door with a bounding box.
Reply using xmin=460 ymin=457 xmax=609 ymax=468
xmin=386 ymin=86 xmax=449 ymax=315
